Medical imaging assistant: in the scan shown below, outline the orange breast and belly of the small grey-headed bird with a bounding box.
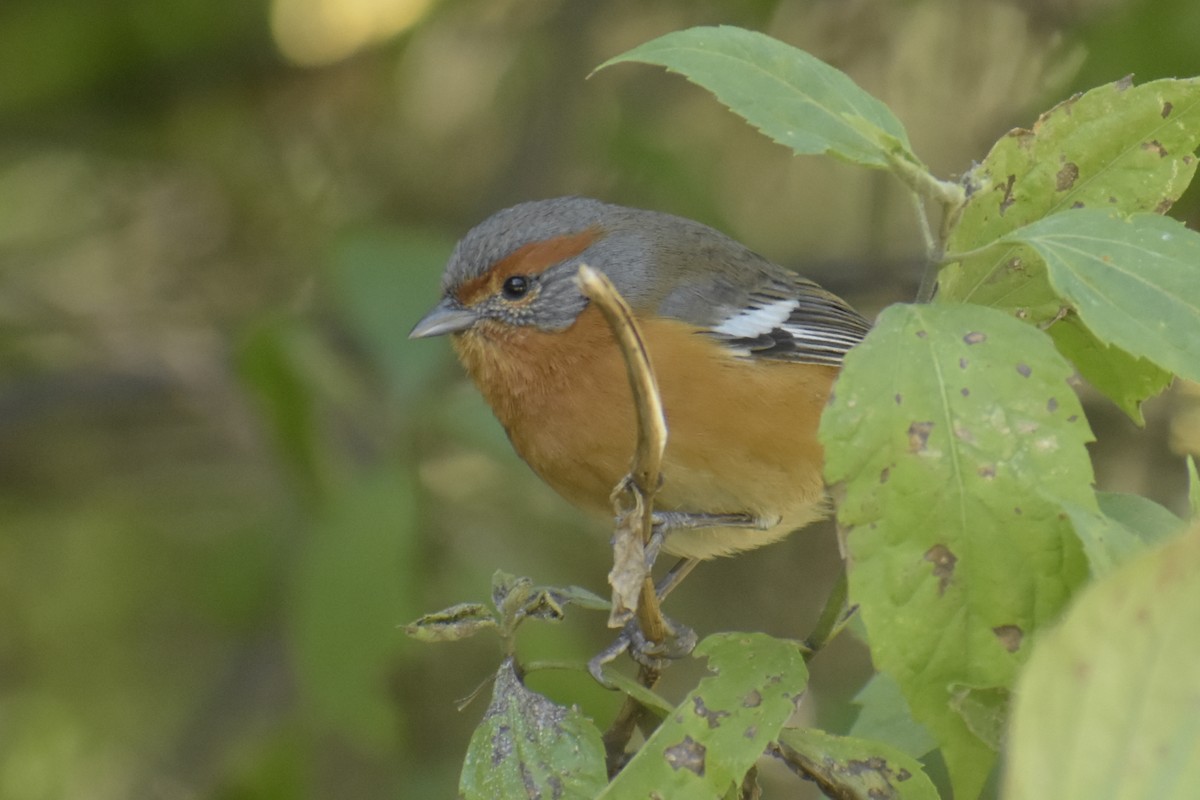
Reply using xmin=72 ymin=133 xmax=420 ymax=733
xmin=456 ymin=308 xmax=836 ymax=558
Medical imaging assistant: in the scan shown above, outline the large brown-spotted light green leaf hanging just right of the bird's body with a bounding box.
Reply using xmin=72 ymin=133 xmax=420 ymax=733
xmin=821 ymin=306 xmax=1096 ymax=798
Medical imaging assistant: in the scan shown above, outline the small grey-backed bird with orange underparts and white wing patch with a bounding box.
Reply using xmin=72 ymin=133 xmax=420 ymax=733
xmin=409 ymin=197 xmax=869 ymax=559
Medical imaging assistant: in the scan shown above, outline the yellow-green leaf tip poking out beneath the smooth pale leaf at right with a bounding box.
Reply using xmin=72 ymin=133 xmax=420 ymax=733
xmin=1048 ymin=314 xmax=1175 ymax=425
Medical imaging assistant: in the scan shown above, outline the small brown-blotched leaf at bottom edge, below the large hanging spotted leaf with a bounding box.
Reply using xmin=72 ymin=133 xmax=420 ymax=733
xmin=779 ymin=728 xmax=937 ymax=800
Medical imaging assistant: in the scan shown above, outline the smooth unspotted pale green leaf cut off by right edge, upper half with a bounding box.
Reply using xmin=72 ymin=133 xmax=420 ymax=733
xmin=1004 ymin=209 xmax=1200 ymax=380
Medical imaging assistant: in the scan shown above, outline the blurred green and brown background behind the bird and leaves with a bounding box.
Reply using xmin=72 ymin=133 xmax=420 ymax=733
xmin=0 ymin=0 xmax=1200 ymax=800
